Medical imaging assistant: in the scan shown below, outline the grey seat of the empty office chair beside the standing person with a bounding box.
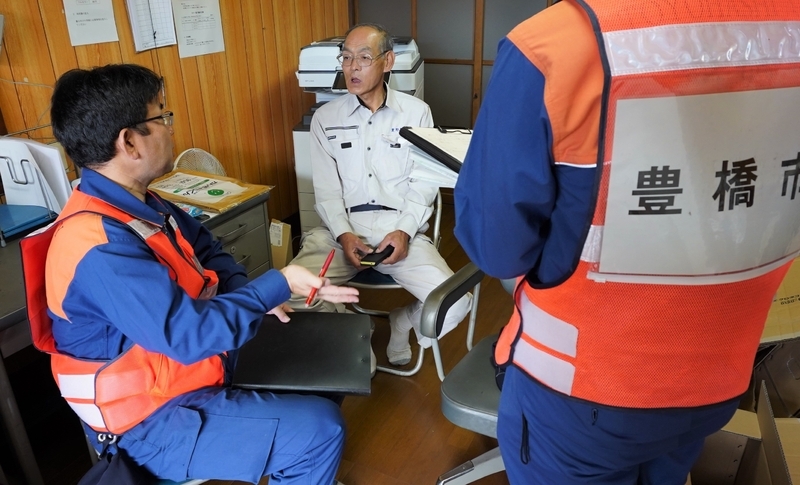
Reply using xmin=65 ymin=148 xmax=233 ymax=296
xmin=441 ymin=335 xmax=500 ymax=438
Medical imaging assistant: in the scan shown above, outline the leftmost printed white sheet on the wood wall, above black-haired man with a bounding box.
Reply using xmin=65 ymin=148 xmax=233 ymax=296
xmin=64 ymin=0 xmax=119 ymax=46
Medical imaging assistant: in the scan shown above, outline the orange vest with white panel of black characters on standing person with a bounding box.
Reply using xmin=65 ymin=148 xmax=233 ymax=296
xmin=495 ymin=0 xmax=800 ymax=408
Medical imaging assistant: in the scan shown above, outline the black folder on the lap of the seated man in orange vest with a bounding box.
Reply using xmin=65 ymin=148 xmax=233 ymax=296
xmin=228 ymin=312 xmax=371 ymax=396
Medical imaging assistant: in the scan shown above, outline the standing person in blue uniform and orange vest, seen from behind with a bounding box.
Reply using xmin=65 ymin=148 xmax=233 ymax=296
xmin=455 ymin=0 xmax=800 ymax=485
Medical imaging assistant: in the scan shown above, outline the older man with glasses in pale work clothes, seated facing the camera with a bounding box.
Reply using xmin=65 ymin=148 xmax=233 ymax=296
xmin=292 ymin=24 xmax=469 ymax=370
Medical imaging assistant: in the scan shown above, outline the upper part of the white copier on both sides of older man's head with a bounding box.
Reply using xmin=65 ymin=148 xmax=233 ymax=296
xmin=296 ymin=37 xmax=425 ymax=102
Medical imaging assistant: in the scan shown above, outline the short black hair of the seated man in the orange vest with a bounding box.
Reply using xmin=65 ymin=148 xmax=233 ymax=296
xmin=50 ymin=64 xmax=163 ymax=168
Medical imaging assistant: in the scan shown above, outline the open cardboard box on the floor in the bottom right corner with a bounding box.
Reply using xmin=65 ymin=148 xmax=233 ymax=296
xmin=691 ymin=382 xmax=800 ymax=485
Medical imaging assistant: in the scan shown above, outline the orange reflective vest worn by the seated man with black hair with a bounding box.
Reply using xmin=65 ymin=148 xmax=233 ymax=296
xmin=20 ymin=190 xmax=224 ymax=434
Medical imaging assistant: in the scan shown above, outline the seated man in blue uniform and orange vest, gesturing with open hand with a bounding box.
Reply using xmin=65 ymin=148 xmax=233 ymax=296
xmin=21 ymin=64 xmax=358 ymax=485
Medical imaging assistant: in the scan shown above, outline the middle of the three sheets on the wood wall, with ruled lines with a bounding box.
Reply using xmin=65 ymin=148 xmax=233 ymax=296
xmin=125 ymin=0 xmax=177 ymax=52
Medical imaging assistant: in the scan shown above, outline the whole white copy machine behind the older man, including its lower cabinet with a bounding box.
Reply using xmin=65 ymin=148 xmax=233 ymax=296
xmin=292 ymin=36 xmax=425 ymax=232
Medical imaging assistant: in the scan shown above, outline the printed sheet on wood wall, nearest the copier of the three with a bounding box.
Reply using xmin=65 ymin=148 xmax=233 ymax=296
xmin=172 ymin=0 xmax=225 ymax=58
